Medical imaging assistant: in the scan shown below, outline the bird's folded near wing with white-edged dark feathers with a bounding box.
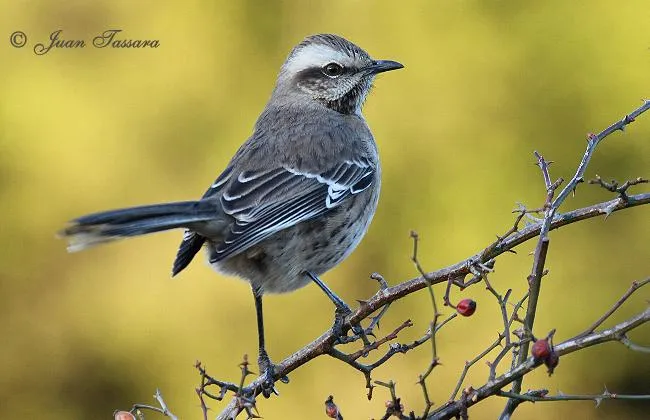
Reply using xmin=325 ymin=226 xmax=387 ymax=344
xmin=211 ymin=158 xmax=376 ymax=262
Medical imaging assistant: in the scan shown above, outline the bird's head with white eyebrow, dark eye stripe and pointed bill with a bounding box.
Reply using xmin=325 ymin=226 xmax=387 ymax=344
xmin=274 ymin=34 xmax=404 ymax=114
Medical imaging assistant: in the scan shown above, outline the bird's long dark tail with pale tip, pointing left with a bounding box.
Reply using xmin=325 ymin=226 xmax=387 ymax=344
xmin=59 ymin=200 xmax=218 ymax=252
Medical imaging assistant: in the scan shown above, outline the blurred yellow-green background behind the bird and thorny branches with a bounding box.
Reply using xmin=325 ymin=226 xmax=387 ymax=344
xmin=0 ymin=0 xmax=650 ymax=420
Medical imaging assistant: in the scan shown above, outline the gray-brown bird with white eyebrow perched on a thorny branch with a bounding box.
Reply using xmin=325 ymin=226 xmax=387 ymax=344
xmin=61 ymin=34 xmax=403 ymax=396
